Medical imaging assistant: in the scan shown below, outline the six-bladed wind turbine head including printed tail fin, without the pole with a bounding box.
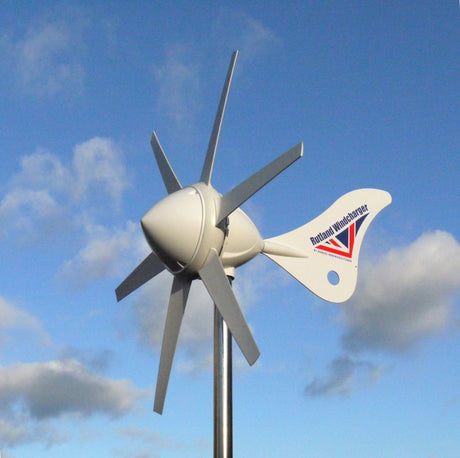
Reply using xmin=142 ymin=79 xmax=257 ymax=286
xmin=116 ymin=52 xmax=391 ymax=414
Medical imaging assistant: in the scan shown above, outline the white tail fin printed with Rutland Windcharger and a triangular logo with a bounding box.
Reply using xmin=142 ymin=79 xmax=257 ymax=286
xmin=262 ymin=189 xmax=391 ymax=302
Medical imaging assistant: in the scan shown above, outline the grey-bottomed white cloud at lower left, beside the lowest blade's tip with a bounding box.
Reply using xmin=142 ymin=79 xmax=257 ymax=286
xmin=0 ymin=359 xmax=149 ymax=445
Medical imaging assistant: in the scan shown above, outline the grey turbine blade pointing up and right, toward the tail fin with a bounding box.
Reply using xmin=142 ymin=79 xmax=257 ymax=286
xmin=217 ymin=143 xmax=303 ymax=224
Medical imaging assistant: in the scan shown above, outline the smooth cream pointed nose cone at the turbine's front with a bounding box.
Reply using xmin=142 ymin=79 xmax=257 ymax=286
xmin=141 ymin=187 xmax=204 ymax=271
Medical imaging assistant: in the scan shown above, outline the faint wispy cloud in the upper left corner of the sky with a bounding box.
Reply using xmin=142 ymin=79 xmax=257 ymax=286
xmin=0 ymin=14 xmax=85 ymax=96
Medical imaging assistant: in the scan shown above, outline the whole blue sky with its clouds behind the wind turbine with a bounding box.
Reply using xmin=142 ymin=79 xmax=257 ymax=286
xmin=0 ymin=0 xmax=460 ymax=458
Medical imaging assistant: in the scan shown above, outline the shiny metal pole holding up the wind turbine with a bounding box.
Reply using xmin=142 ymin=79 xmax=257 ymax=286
xmin=214 ymin=277 xmax=233 ymax=458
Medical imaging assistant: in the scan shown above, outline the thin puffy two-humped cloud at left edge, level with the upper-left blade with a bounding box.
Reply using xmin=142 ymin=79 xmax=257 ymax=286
xmin=0 ymin=137 xmax=128 ymax=242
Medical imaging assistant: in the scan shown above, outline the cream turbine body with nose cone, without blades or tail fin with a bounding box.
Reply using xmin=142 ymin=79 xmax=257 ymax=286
xmin=141 ymin=183 xmax=264 ymax=278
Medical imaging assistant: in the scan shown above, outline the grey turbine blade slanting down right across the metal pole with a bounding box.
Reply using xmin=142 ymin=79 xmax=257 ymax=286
xmin=198 ymin=250 xmax=260 ymax=366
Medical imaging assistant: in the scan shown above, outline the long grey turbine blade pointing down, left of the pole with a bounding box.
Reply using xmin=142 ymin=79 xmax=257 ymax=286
xmin=153 ymin=277 xmax=191 ymax=415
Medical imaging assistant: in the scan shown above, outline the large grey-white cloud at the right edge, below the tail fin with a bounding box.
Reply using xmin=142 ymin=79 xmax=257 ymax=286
xmin=341 ymin=231 xmax=460 ymax=352
